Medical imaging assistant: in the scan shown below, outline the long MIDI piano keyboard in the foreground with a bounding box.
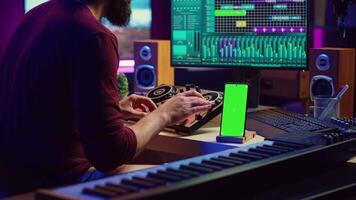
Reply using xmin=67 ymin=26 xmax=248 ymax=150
xmin=36 ymin=138 xmax=355 ymax=200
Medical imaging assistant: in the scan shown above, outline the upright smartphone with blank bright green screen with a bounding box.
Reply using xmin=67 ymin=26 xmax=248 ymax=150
xmin=220 ymin=84 xmax=248 ymax=137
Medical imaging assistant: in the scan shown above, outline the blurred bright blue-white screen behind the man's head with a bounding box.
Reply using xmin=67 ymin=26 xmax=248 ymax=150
xmin=24 ymin=0 xmax=152 ymax=59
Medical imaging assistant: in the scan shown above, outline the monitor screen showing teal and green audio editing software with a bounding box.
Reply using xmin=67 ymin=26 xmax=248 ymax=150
xmin=172 ymin=0 xmax=308 ymax=69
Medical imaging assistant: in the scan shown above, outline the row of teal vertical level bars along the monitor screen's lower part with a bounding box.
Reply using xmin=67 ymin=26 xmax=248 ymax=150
xmin=202 ymin=36 xmax=306 ymax=67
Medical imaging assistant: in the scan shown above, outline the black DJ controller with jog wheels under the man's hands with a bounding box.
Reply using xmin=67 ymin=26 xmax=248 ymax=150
xmin=147 ymin=84 xmax=223 ymax=134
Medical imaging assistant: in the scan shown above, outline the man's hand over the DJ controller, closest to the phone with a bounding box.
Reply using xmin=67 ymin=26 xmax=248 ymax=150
xmin=157 ymin=90 xmax=212 ymax=125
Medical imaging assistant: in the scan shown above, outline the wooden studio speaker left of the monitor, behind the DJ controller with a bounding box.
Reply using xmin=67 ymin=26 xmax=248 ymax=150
xmin=134 ymin=40 xmax=174 ymax=93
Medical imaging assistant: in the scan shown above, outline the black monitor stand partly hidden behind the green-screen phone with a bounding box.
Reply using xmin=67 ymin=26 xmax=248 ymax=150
xmin=234 ymin=68 xmax=261 ymax=108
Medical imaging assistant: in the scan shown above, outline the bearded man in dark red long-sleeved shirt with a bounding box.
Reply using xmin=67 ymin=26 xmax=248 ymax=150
xmin=0 ymin=0 xmax=211 ymax=193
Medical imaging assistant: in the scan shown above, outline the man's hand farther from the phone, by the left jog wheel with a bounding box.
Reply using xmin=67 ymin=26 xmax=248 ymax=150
xmin=119 ymin=94 xmax=157 ymax=119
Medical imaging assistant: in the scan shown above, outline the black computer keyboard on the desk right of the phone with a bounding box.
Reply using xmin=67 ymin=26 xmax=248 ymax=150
xmin=248 ymin=109 xmax=336 ymax=133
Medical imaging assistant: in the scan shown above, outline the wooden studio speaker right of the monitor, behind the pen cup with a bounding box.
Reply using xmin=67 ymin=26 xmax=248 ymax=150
xmin=309 ymin=48 xmax=355 ymax=117
